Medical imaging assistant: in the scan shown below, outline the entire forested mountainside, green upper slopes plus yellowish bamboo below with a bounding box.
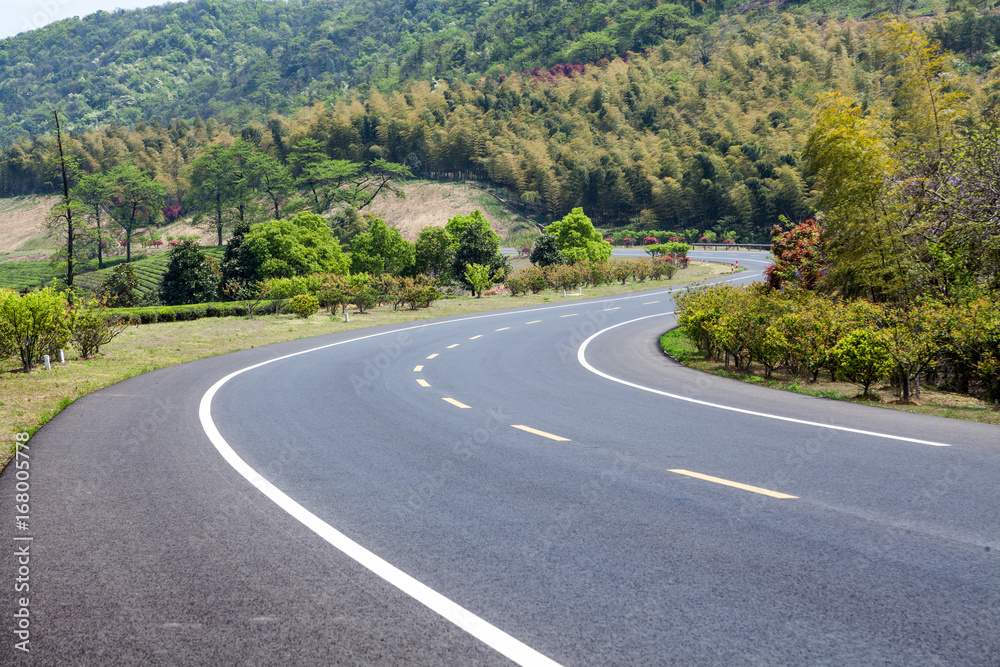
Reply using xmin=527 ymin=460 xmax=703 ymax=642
xmin=0 ymin=0 xmax=1000 ymax=241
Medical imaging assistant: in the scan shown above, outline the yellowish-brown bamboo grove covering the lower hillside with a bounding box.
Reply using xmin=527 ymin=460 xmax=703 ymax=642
xmin=0 ymin=9 xmax=996 ymax=242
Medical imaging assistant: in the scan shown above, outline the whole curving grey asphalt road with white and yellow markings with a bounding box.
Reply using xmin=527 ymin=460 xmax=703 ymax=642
xmin=0 ymin=252 xmax=1000 ymax=665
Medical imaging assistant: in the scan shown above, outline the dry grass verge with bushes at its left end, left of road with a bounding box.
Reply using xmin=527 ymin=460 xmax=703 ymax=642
xmin=0 ymin=259 xmax=730 ymax=470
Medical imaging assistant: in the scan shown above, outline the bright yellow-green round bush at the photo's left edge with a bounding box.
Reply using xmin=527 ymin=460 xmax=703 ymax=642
xmin=0 ymin=287 xmax=69 ymax=373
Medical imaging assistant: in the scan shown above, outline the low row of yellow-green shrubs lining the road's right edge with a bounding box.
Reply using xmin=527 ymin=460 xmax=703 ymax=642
xmin=676 ymin=284 xmax=1000 ymax=402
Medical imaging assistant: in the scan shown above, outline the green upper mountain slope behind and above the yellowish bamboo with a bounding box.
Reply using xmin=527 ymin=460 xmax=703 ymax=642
xmin=0 ymin=0 xmax=710 ymax=141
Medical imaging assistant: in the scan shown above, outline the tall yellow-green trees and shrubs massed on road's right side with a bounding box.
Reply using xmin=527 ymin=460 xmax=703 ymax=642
xmin=668 ymin=23 xmax=1000 ymax=422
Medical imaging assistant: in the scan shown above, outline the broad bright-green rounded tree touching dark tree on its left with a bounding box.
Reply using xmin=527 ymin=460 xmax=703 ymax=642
xmin=240 ymin=212 xmax=348 ymax=279
